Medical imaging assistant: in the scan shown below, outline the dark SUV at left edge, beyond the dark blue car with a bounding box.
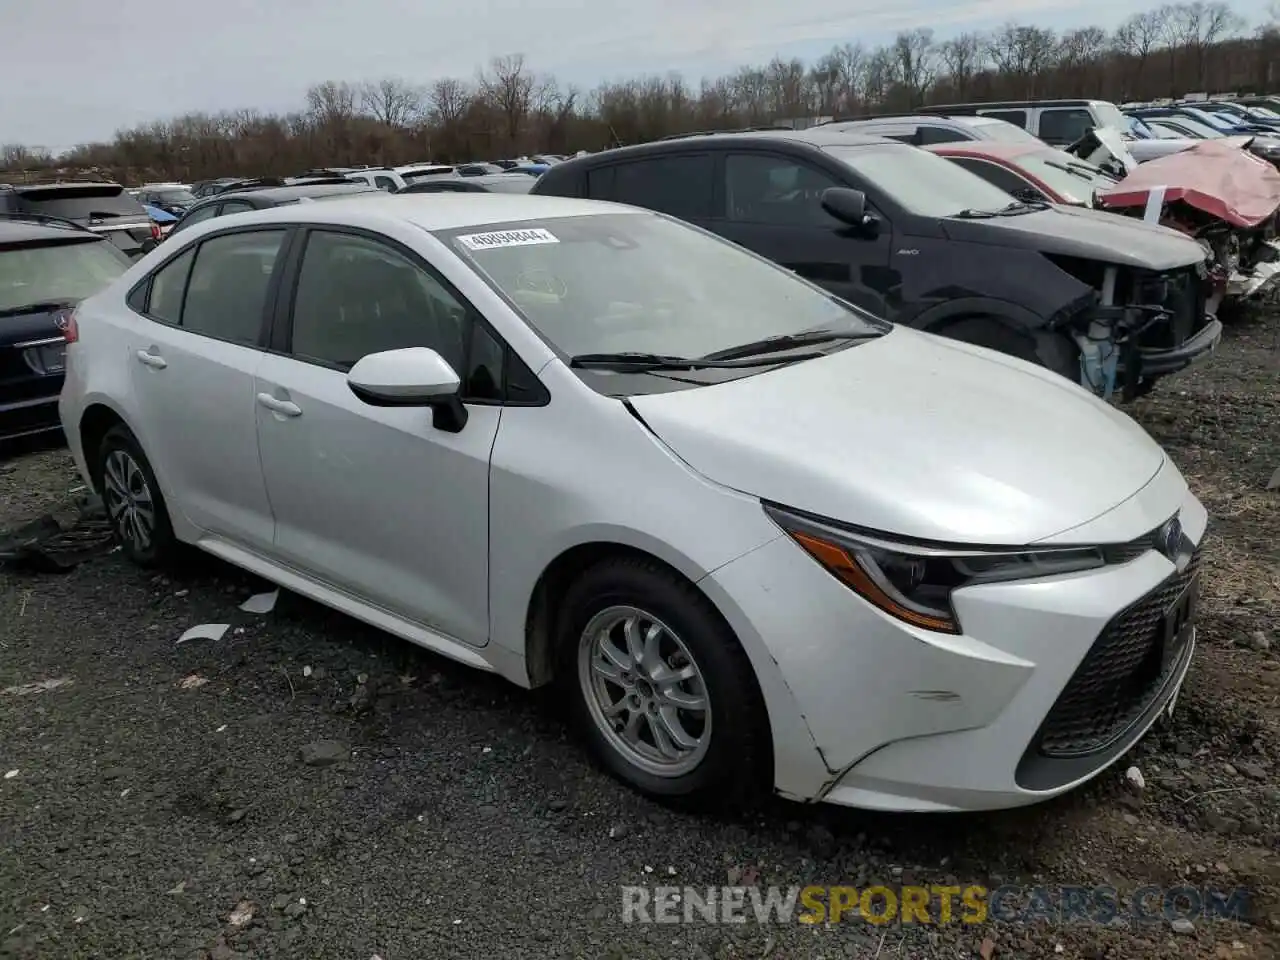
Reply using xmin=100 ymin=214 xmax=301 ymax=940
xmin=0 ymin=180 xmax=160 ymax=259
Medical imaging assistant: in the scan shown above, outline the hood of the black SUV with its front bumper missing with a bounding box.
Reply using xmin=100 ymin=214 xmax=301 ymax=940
xmin=942 ymin=206 xmax=1204 ymax=271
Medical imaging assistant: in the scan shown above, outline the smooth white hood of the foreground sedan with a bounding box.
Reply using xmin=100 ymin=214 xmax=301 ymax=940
xmin=628 ymin=326 xmax=1165 ymax=545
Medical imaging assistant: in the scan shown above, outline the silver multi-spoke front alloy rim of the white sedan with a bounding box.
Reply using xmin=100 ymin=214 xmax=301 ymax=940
xmin=577 ymin=607 xmax=712 ymax=777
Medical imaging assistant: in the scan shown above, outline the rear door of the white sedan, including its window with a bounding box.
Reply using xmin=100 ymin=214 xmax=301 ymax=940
xmin=128 ymin=229 xmax=285 ymax=550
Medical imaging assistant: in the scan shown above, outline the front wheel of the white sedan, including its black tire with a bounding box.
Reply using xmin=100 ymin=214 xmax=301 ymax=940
xmin=557 ymin=558 xmax=773 ymax=809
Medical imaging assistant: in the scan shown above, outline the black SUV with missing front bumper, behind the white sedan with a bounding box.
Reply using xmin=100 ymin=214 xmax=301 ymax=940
xmin=532 ymin=127 xmax=1222 ymax=397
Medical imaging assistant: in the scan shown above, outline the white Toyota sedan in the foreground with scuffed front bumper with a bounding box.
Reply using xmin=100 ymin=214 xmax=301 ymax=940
xmin=60 ymin=193 xmax=1207 ymax=810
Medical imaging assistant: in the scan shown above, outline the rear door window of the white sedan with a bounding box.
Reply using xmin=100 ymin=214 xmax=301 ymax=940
xmin=182 ymin=230 xmax=284 ymax=344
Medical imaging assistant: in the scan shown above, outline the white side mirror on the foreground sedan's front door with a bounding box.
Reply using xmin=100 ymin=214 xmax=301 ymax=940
xmin=347 ymin=347 xmax=467 ymax=433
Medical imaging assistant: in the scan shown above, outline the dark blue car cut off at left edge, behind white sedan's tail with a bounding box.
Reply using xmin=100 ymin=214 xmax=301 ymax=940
xmin=0 ymin=214 xmax=131 ymax=439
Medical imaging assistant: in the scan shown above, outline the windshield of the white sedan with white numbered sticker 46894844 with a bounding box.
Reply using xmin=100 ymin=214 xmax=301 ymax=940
xmin=438 ymin=212 xmax=885 ymax=357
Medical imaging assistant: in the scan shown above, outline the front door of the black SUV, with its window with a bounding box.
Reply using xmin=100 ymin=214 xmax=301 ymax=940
xmin=716 ymin=152 xmax=892 ymax=319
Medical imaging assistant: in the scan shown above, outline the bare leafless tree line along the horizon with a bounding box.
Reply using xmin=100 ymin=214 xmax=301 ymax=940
xmin=0 ymin=0 xmax=1280 ymax=183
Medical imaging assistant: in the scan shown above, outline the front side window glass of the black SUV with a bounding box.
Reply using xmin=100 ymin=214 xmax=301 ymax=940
xmin=724 ymin=154 xmax=842 ymax=227
